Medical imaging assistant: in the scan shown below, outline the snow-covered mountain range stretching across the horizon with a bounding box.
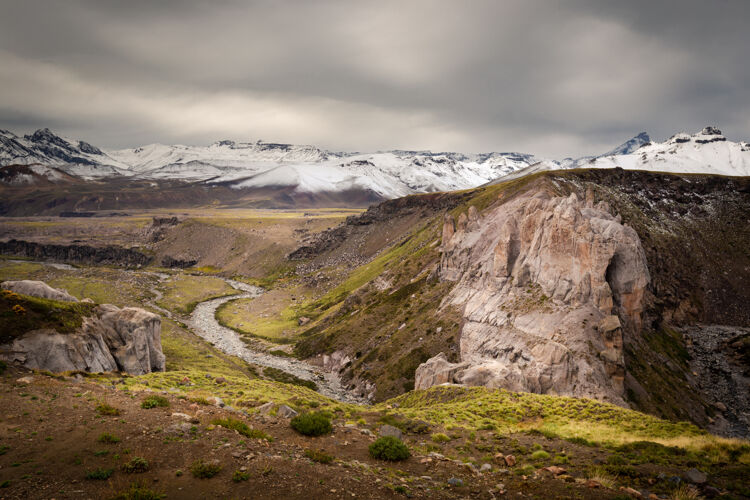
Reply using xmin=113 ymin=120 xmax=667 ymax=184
xmin=0 ymin=127 xmax=750 ymax=199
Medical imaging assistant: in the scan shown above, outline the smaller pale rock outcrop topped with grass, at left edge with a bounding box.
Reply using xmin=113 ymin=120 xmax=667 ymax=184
xmin=0 ymin=282 xmax=165 ymax=375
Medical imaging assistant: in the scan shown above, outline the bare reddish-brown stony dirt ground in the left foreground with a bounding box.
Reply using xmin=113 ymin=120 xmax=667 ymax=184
xmin=0 ymin=368 xmax=628 ymax=499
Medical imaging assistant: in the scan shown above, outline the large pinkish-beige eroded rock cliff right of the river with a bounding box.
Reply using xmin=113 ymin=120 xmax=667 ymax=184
xmin=415 ymin=191 xmax=649 ymax=404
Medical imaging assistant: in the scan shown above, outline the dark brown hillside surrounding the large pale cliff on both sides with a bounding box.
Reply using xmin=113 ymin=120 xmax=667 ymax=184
xmin=286 ymin=170 xmax=750 ymax=435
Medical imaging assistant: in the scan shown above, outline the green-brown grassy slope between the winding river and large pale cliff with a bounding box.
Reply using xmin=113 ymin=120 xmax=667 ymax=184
xmin=296 ymin=175 xmax=552 ymax=400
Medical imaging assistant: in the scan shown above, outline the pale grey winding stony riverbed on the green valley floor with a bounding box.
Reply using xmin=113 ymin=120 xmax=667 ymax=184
xmin=188 ymin=279 xmax=365 ymax=403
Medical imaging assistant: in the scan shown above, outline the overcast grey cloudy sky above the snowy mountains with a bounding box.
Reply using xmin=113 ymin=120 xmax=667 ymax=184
xmin=0 ymin=0 xmax=750 ymax=158
